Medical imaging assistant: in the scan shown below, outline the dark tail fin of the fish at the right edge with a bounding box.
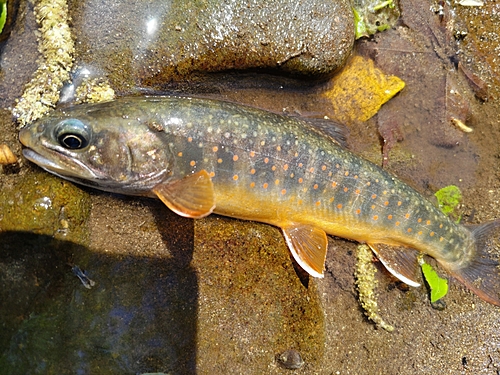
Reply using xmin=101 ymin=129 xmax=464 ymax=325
xmin=452 ymin=220 xmax=500 ymax=306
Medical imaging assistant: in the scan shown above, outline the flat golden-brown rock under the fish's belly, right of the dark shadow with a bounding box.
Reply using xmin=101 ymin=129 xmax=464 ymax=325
xmin=192 ymin=216 xmax=325 ymax=374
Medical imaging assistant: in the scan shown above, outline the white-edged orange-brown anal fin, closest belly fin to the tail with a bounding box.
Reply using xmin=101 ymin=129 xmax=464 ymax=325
xmin=368 ymin=243 xmax=420 ymax=287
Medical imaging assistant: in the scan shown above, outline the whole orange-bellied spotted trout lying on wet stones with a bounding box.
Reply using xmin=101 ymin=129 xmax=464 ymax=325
xmin=19 ymin=96 xmax=500 ymax=306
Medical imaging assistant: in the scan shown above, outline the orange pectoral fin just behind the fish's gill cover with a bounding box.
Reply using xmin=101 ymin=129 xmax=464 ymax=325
xmin=153 ymin=170 xmax=215 ymax=219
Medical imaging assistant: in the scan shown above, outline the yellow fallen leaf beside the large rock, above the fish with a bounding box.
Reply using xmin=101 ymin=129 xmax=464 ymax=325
xmin=324 ymin=56 xmax=405 ymax=123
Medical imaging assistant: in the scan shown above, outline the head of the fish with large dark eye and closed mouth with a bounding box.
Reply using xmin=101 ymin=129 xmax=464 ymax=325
xmin=19 ymin=111 xmax=173 ymax=195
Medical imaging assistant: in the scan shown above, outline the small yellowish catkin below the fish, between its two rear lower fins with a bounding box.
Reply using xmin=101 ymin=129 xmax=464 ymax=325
xmin=355 ymin=245 xmax=394 ymax=332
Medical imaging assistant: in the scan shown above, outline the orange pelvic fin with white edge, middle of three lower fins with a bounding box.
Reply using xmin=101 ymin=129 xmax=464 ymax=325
xmin=282 ymin=225 xmax=328 ymax=277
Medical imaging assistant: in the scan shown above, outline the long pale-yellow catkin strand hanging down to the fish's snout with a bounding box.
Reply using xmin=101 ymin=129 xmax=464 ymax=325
xmin=13 ymin=0 xmax=74 ymax=126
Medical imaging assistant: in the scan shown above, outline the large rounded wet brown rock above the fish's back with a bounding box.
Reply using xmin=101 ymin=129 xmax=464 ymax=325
xmin=72 ymin=0 xmax=354 ymax=90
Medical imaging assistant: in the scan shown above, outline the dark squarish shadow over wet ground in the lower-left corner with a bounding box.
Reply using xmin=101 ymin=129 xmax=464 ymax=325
xmin=0 ymin=231 xmax=198 ymax=374
